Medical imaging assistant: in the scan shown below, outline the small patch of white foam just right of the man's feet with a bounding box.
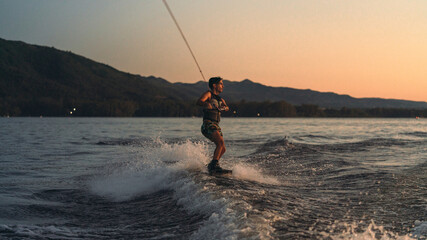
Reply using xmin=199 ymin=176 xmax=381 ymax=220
xmin=233 ymin=164 xmax=280 ymax=185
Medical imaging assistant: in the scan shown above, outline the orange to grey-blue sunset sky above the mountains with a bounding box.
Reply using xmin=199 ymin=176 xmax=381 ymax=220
xmin=0 ymin=0 xmax=427 ymax=101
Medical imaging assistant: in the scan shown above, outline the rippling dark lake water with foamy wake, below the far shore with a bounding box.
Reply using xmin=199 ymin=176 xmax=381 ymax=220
xmin=0 ymin=118 xmax=427 ymax=239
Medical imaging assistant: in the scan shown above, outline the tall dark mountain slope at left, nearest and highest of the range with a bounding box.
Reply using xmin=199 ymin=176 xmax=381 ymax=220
xmin=0 ymin=39 xmax=196 ymax=116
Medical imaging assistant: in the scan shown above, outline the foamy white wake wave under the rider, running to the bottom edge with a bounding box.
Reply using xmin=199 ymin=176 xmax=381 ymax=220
xmin=88 ymin=139 xmax=279 ymax=239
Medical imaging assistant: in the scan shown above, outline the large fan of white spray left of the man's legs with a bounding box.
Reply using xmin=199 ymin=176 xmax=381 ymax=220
xmin=89 ymin=141 xmax=211 ymax=201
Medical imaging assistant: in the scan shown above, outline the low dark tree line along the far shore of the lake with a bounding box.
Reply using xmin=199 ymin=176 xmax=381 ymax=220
xmin=0 ymin=98 xmax=427 ymax=118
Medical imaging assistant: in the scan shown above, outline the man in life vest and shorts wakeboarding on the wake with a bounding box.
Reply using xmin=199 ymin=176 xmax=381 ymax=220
xmin=197 ymin=77 xmax=231 ymax=174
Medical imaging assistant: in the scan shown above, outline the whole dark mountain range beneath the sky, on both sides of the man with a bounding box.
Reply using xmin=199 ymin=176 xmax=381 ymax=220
xmin=0 ymin=38 xmax=427 ymax=116
